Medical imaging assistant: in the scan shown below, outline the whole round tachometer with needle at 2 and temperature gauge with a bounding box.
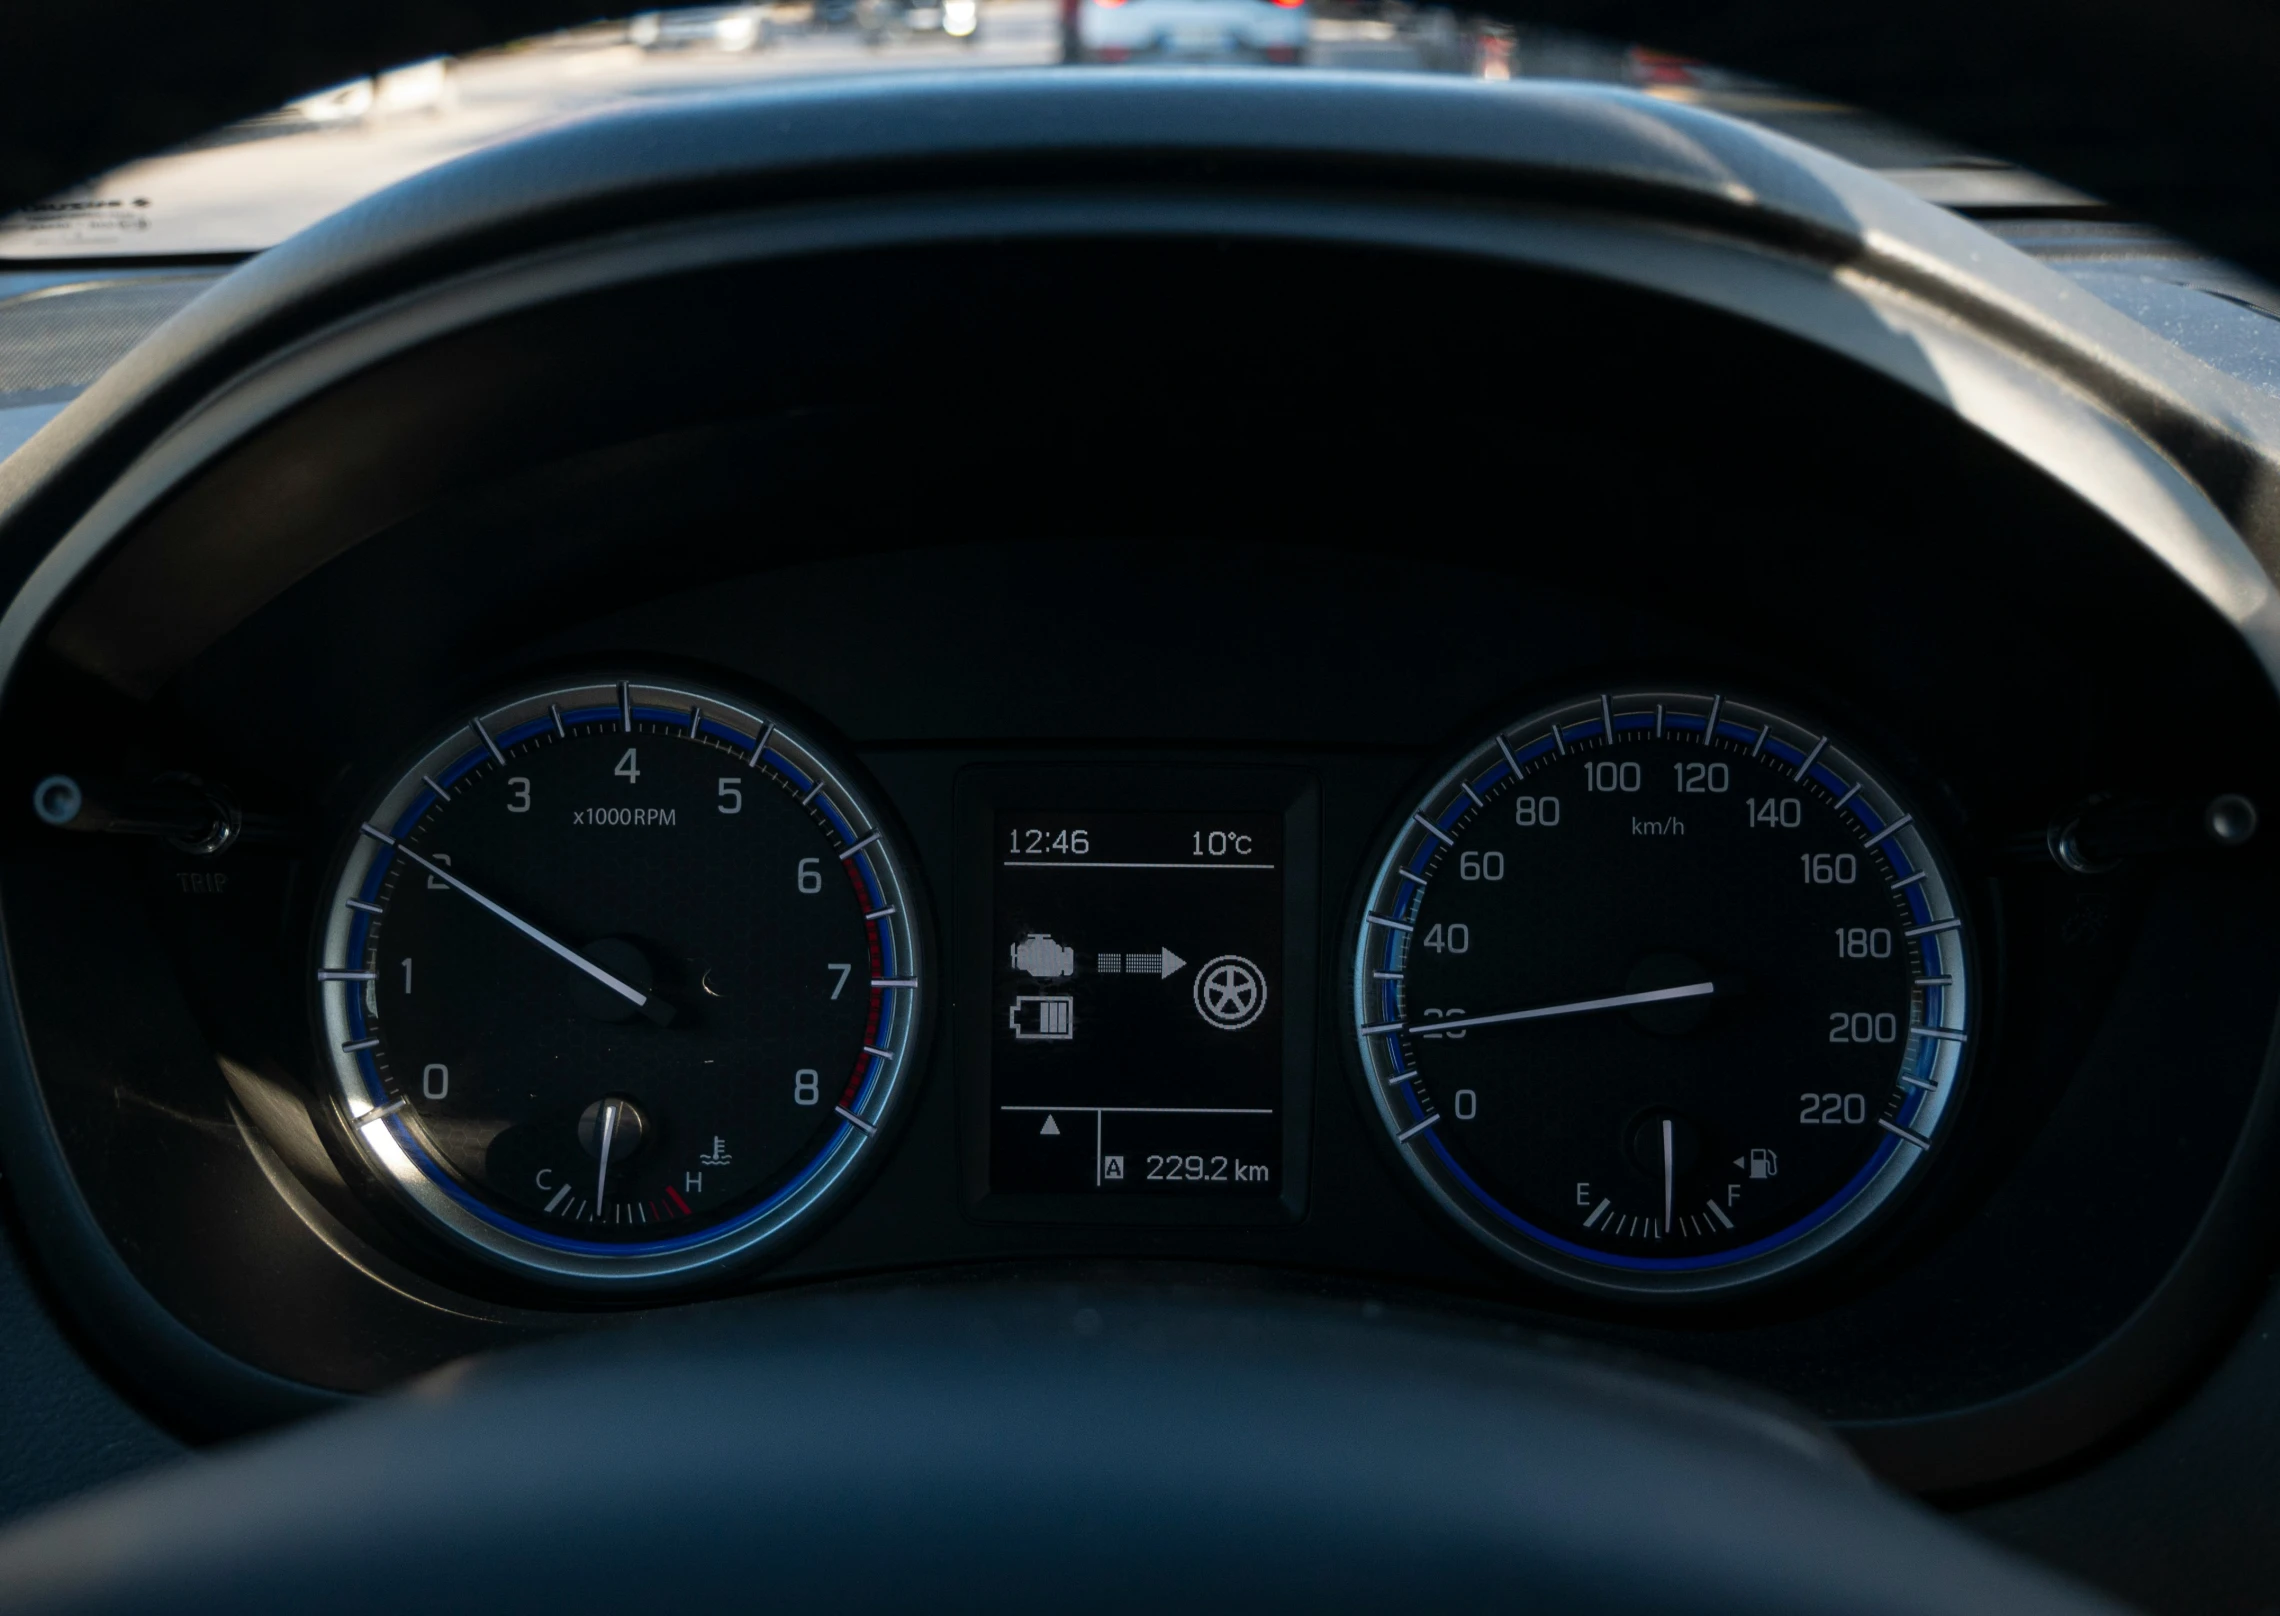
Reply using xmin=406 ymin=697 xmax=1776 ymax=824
xmin=317 ymin=682 xmax=923 ymax=1283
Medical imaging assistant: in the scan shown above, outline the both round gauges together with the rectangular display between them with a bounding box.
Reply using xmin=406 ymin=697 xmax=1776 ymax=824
xmin=289 ymin=670 xmax=1974 ymax=1295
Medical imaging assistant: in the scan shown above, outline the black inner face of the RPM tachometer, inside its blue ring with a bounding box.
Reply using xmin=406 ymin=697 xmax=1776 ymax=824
xmin=358 ymin=720 xmax=869 ymax=1244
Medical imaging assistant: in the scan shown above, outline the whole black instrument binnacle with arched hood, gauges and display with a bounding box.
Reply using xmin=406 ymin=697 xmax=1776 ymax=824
xmin=0 ymin=62 xmax=2280 ymax=1604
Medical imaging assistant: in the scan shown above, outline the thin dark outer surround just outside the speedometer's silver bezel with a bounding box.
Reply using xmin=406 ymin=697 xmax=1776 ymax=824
xmin=1332 ymin=661 xmax=2027 ymax=1331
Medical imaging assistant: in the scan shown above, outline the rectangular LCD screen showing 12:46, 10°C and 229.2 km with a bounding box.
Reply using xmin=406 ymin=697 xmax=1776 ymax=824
xmin=990 ymin=807 xmax=1286 ymax=1199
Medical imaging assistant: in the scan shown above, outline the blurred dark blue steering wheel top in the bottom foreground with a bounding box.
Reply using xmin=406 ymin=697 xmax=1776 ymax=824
xmin=0 ymin=1283 xmax=2114 ymax=1616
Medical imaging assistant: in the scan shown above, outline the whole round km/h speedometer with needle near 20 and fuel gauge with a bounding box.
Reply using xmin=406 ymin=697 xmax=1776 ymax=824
xmin=1352 ymin=693 xmax=1970 ymax=1295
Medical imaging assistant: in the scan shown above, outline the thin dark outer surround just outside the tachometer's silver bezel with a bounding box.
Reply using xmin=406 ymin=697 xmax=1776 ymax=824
xmin=303 ymin=670 xmax=942 ymax=1331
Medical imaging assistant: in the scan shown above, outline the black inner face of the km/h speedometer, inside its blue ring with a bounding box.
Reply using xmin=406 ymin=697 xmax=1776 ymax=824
xmin=1382 ymin=720 xmax=1920 ymax=1258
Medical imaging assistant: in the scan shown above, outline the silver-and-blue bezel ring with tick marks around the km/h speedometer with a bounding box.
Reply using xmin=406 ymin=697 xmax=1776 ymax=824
xmin=1343 ymin=684 xmax=1977 ymax=1301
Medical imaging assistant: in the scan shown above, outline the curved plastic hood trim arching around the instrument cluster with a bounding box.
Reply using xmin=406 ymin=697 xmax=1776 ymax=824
xmin=0 ymin=73 xmax=2280 ymax=1458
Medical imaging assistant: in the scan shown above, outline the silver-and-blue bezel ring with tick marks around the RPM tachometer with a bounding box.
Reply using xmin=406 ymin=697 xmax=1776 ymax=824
xmin=312 ymin=677 xmax=933 ymax=1290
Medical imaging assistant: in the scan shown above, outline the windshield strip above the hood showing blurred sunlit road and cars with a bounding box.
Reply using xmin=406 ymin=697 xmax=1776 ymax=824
xmin=0 ymin=0 xmax=2088 ymax=262
